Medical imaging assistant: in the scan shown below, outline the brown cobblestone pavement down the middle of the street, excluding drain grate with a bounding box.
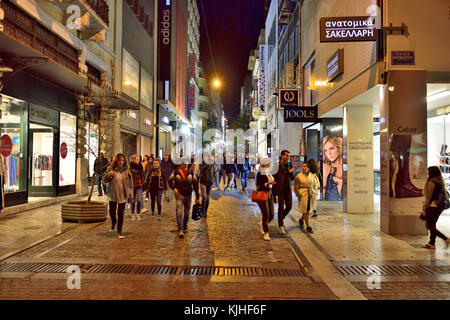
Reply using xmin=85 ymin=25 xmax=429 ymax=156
xmin=0 ymin=181 xmax=336 ymax=300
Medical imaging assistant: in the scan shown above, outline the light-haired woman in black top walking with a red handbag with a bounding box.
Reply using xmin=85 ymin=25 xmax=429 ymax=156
xmin=256 ymin=159 xmax=276 ymax=241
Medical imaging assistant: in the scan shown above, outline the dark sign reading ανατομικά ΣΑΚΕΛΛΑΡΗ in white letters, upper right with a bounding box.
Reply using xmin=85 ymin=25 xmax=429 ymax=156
xmin=320 ymin=16 xmax=377 ymax=42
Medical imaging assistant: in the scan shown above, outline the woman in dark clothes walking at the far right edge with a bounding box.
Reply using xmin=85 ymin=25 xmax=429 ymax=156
xmin=422 ymin=166 xmax=450 ymax=249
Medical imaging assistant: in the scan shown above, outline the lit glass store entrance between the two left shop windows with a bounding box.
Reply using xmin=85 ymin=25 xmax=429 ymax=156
xmin=28 ymin=124 xmax=58 ymax=197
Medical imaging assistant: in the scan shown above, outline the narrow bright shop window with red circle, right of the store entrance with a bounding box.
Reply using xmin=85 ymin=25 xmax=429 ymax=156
xmin=59 ymin=112 xmax=77 ymax=186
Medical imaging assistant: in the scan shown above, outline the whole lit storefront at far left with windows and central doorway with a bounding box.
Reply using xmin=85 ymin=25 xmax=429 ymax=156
xmin=0 ymin=73 xmax=77 ymax=207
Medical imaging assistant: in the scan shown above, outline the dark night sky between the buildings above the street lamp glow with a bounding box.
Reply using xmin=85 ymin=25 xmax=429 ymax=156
xmin=197 ymin=0 xmax=265 ymax=119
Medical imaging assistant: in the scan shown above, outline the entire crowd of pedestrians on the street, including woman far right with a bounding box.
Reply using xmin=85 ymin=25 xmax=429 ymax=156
xmin=94 ymin=150 xmax=450 ymax=249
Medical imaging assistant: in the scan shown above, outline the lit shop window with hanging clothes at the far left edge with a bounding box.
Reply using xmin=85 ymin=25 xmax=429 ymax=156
xmin=0 ymin=94 xmax=28 ymax=193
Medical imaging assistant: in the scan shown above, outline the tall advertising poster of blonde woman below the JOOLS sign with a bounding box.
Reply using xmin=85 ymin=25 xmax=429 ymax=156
xmin=322 ymin=119 xmax=344 ymax=201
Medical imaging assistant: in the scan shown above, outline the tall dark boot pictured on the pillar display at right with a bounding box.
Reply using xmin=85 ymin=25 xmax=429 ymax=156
xmin=391 ymin=135 xmax=423 ymax=198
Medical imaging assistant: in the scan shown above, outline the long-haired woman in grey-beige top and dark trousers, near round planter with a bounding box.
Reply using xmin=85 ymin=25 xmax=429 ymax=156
xmin=104 ymin=153 xmax=133 ymax=239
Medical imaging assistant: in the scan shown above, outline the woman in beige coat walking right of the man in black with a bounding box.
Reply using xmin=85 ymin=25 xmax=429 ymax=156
xmin=294 ymin=163 xmax=313 ymax=233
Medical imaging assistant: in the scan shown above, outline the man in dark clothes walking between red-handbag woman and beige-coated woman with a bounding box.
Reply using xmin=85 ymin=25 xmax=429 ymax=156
xmin=274 ymin=150 xmax=295 ymax=235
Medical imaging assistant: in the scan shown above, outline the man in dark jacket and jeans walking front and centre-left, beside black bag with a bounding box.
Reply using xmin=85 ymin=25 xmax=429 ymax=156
xmin=169 ymin=162 xmax=200 ymax=239
